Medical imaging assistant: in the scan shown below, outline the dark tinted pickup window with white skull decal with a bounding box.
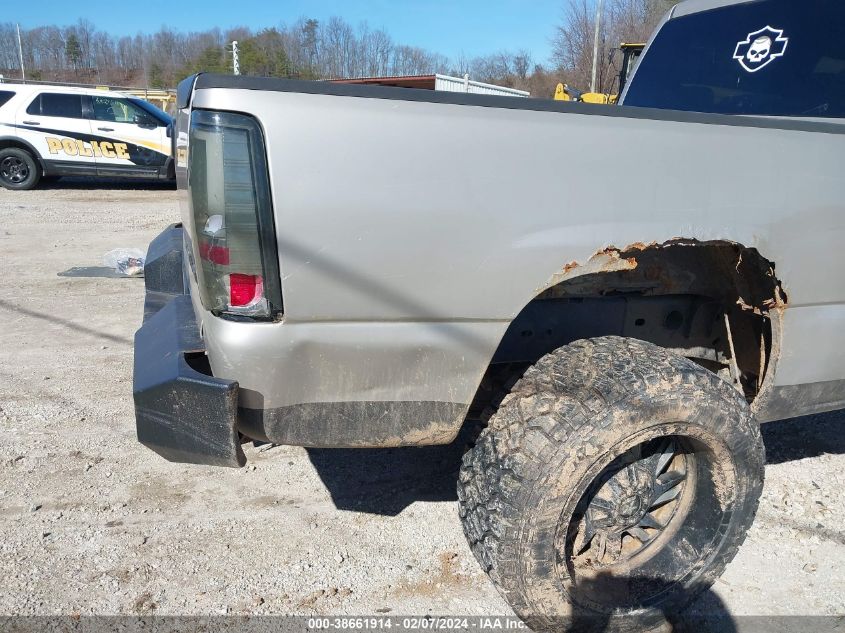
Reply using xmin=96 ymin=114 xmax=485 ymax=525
xmin=624 ymin=0 xmax=845 ymax=117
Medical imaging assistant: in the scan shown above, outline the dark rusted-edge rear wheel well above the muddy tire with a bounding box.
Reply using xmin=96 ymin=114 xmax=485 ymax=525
xmin=470 ymin=239 xmax=787 ymax=417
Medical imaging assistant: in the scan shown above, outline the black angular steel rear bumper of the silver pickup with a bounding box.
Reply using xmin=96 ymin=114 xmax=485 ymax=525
xmin=132 ymin=225 xmax=246 ymax=467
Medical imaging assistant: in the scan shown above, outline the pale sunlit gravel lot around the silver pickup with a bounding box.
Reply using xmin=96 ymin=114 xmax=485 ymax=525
xmin=0 ymin=181 xmax=845 ymax=615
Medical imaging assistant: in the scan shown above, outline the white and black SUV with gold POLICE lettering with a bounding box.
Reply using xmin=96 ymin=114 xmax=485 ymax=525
xmin=0 ymin=84 xmax=174 ymax=189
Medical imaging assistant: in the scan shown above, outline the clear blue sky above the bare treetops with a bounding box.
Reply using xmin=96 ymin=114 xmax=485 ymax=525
xmin=29 ymin=0 xmax=563 ymax=62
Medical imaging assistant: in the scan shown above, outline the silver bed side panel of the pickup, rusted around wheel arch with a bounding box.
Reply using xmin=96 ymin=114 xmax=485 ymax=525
xmin=185 ymin=88 xmax=845 ymax=434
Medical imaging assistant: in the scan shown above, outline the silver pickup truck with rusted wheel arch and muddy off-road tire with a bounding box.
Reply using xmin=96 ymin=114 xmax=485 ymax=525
xmin=134 ymin=0 xmax=845 ymax=630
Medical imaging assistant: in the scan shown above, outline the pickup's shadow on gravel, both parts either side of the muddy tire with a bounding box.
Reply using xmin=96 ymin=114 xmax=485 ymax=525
xmin=308 ymin=411 xmax=845 ymax=516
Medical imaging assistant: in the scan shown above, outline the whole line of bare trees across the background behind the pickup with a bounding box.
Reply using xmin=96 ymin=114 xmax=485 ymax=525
xmin=0 ymin=0 xmax=673 ymax=97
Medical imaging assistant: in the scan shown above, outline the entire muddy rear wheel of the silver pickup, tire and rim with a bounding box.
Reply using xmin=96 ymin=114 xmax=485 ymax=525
xmin=458 ymin=337 xmax=764 ymax=631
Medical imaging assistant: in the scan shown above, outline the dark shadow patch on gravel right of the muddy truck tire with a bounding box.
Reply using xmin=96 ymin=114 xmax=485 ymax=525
xmin=760 ymin=411 xmax=845 ymax=464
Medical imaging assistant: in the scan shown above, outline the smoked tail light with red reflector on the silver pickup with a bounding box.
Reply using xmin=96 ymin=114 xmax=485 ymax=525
xmin=188 ymin=110 xmax=283 ymax=319
